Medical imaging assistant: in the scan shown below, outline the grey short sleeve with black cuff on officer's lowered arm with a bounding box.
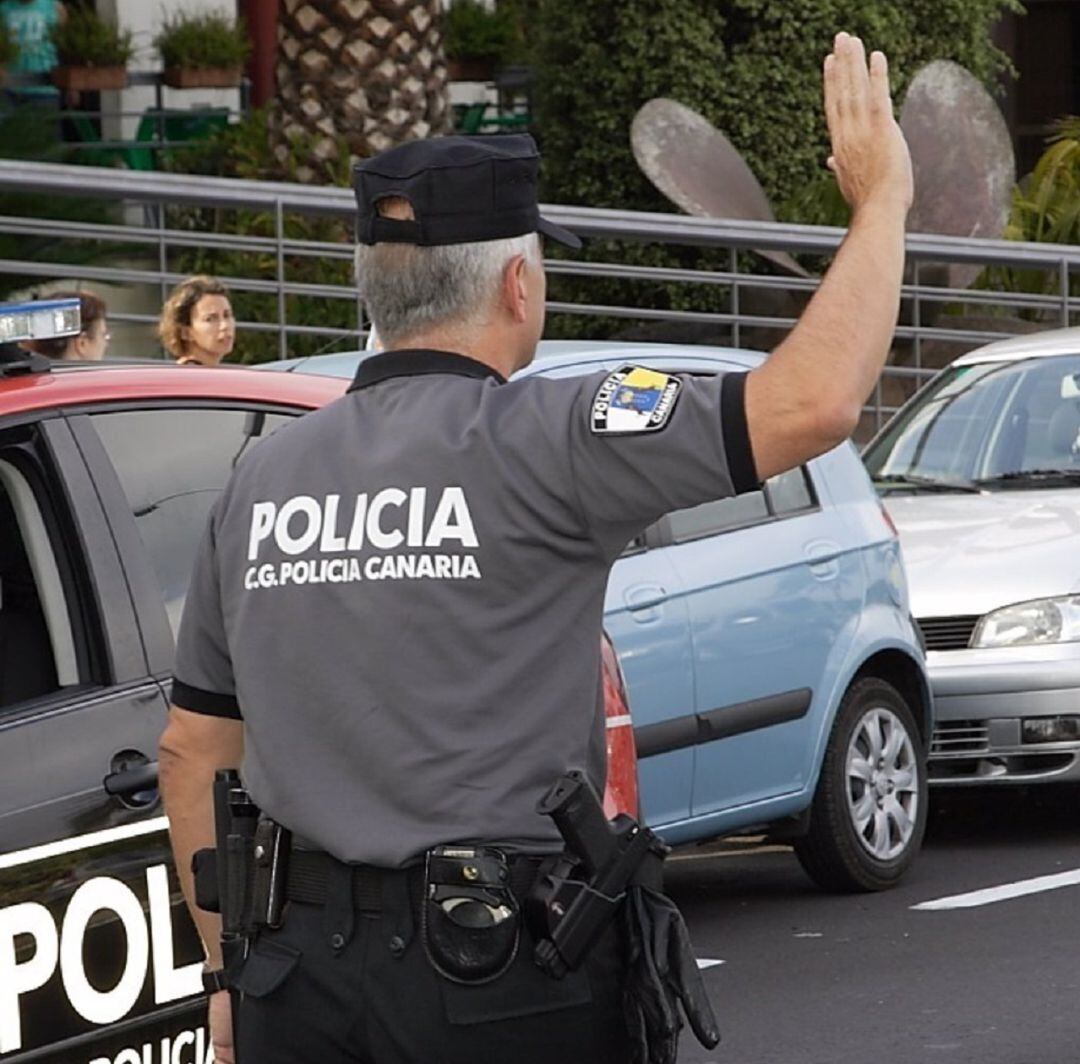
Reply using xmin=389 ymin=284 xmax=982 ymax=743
xmin=172 ymin=500 xmax=241 ymax=719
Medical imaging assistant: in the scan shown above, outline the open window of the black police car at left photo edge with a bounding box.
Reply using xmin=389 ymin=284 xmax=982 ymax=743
xmin=0 ymin=458 xmax=79 ymax=706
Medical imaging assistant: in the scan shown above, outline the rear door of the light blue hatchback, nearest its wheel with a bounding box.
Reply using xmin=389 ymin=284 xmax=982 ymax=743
xmin=662 ymin=458 xmax=862 ymax=817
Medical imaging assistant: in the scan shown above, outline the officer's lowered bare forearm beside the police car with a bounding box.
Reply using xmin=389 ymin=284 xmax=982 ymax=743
xmin=158 ymin=705 xmax=244 ymax=968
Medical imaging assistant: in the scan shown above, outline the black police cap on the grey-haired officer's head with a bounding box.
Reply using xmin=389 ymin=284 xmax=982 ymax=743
xmin=353 ymin=133 xmax=581 ymax=247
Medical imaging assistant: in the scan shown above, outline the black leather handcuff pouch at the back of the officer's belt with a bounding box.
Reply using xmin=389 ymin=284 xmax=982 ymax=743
xmin=420 ymin=846 xmax=521 ymax=984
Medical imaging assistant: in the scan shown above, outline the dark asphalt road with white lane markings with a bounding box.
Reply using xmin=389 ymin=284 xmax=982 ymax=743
xmin=666 ymin=786 xmax=1080 ymax=1064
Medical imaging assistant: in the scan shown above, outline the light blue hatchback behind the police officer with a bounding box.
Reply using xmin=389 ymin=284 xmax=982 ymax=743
xmin=267 ymin=342 xmax=932 ymax=890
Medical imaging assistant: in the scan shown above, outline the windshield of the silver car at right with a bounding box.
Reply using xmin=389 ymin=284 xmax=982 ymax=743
xmin=863 ymin=355 xmax=1080 ymax=490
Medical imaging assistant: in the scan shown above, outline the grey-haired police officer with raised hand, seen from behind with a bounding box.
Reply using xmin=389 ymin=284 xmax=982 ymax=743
xmin=160 ymin=33 xmax=912 ymax=1064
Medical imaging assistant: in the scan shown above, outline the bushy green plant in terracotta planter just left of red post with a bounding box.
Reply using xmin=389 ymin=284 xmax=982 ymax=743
xmin=153 ymin=11 xmax=252 ymax=89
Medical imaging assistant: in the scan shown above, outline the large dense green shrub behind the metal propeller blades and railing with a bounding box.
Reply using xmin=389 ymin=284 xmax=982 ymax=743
xmin=530 ymin=0 xmax=1021 ymax=333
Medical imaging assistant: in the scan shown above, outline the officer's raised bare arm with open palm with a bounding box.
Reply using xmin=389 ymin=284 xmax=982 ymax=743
xmin=745 ymin=33 xmax=912 ymax=481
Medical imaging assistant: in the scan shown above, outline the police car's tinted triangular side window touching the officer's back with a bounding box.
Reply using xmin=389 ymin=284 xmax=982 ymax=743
xmin=91 ymin=407 xmax=294 ymax=633
